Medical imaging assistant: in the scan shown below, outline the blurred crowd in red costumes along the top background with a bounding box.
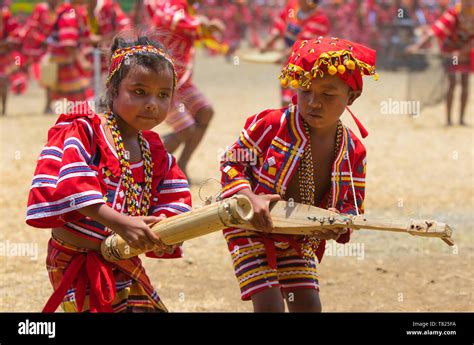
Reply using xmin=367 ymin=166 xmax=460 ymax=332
xmin=0 ymin=0 xmax=468 ymax=111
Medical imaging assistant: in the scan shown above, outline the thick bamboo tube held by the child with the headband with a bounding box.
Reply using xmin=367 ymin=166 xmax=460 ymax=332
xmin=101 ymin=195 xmax=253 ymax=261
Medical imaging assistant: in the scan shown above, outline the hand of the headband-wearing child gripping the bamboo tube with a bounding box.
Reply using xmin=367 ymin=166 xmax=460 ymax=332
xmin=113 ymin=216 xmax=166 ymax=250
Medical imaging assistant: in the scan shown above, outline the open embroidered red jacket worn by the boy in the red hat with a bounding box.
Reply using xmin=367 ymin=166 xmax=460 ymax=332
xmin=221 ymin=105 xmax=366 ymax=261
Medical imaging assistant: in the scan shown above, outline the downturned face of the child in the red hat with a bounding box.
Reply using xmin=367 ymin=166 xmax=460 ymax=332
xmin=298 ymin=74 xmax=361 ymax=128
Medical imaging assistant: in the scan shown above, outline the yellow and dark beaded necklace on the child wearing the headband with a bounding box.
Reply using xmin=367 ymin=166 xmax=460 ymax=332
xmin=106 ymin=111 xmax=153 ymax=216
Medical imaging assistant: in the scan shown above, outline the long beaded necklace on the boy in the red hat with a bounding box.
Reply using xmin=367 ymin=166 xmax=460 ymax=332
xmin=298 ymin=120 xmax=342 ymax=264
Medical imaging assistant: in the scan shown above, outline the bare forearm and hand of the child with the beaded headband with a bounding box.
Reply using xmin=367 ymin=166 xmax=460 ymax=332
xmin=78 ymin=204 xmax=168 ymax=250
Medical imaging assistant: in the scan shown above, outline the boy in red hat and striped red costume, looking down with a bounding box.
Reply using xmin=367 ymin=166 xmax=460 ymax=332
xmin=221 ymin=38 xmax=375 ymax=312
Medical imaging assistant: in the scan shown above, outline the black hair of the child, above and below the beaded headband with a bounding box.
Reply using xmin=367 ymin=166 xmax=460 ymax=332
xmin=105 ymin=34 xmax=176 ymax=109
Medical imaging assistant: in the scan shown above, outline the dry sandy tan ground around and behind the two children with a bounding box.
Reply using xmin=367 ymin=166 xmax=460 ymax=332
xmin=0 ymin=54 xmax=474 ymax=312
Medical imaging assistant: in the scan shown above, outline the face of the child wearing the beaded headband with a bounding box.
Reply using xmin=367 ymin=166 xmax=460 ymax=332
xmin=113 ymin=64 xmax=173 ymax=130
